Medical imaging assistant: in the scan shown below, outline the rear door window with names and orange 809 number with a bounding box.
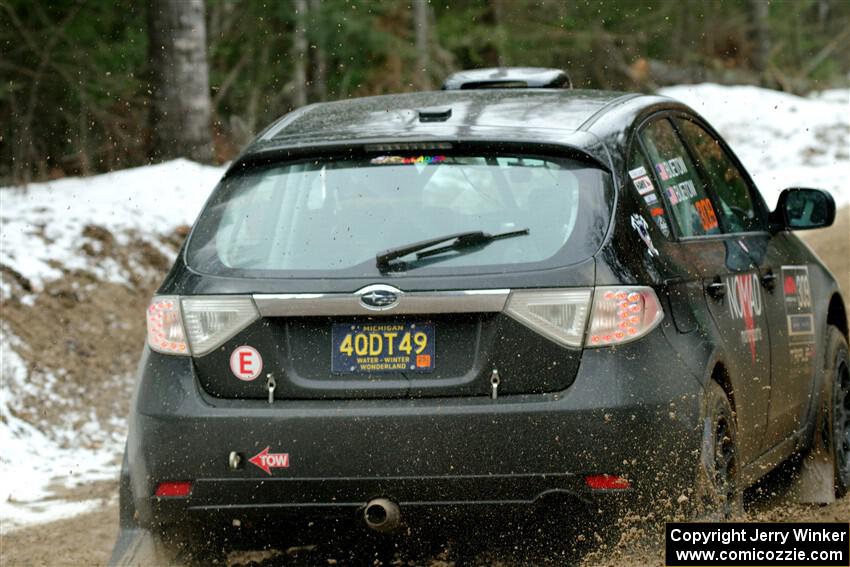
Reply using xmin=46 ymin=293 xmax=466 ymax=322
xmin=640 ymin=119 xmax=720 ymax=237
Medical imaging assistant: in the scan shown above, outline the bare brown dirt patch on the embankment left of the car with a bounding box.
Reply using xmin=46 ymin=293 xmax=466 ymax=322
xmin=0 ymin=225 xmax=188 ymax=449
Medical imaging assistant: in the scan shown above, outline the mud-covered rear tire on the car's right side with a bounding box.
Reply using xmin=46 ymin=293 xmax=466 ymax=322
xmin=698 ymin=381 xmax=744 ymax=520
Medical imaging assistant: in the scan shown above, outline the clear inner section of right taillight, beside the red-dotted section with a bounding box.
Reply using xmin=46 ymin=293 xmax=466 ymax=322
xmin=506 ymin=288 xmax=591 ymax=347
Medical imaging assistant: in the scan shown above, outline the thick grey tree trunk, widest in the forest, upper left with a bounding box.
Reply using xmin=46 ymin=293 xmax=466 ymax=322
xmin=148 ymin=0 xmax=213 ymax=162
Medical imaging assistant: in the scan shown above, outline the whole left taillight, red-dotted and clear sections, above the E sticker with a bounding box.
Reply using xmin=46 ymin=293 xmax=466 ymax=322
xmin=147 ymin=296 xmax=259 ymax=356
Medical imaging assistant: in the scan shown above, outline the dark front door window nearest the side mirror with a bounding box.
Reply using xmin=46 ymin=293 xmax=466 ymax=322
xmin=676 ymin=120 xmax=763 ymax=232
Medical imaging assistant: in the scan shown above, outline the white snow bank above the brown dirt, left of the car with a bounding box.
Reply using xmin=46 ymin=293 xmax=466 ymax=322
xmin=0 ymin=160 xmax=224 ymax=296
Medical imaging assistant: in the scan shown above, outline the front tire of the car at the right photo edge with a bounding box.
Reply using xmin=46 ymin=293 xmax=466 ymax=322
xmin=820 ymin=327 xmax=850 ymax=498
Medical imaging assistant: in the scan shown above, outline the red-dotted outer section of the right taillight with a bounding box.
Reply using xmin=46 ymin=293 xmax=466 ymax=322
xmin=587 ymin=287 xmax=664 ymax=347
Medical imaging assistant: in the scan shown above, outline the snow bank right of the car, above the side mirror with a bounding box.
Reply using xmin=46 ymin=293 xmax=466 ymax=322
xmin=659 ymin=84 xmax=850 ymax=208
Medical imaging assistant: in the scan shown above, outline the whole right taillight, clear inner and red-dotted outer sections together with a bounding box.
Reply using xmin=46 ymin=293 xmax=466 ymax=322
xmin=506 ymin=286 xmax=664 ymax=348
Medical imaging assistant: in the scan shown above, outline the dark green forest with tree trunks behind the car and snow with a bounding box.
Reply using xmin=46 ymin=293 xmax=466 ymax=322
xmin=0 ymin=0 xmax=850 ymax=186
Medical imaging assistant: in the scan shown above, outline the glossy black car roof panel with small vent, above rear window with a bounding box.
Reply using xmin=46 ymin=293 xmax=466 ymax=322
xmin=245 ymin=89 xmax=636 ymax=149
